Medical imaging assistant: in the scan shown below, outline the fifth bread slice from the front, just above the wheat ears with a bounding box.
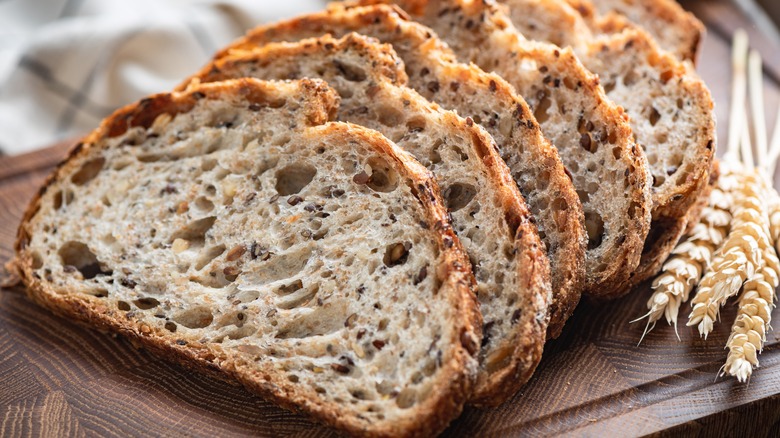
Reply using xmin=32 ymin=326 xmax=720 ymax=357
xmin=502 ymin=0 xmax=715 ymax=289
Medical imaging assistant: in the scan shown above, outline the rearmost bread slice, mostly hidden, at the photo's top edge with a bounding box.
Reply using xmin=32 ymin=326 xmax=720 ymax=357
xmin=566 ymin=0 xmax=706 ymax=63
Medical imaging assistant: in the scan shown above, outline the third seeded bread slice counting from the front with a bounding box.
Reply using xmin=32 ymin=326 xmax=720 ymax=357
xmin=216 ymin=5 xmax=587 ymax=346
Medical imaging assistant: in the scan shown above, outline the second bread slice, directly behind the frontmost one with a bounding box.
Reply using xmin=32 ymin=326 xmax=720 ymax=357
xmin=186 ymin=34 xmax=550 ymax=404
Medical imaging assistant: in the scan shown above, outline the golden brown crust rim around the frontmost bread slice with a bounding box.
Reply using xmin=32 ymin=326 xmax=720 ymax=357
xmin=14 ymin=79 xmax=481 ymax=436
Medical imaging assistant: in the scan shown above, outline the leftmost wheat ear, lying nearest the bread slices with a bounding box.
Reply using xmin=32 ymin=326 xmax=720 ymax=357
xmin=632 ymin=180 xmax=736 ymax=343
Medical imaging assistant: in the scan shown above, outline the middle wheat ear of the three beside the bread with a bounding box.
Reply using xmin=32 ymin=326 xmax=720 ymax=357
xmin=687 ymin=169 xmax=774 ymax=339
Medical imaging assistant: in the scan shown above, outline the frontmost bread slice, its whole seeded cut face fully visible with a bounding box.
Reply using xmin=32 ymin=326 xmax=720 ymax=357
xmin=14 ymin=79 xmax=481 ymax=436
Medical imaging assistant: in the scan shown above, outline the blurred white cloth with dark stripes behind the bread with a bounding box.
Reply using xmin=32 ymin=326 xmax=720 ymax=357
xmin=0 ymin=0 xmax=326 ymax=154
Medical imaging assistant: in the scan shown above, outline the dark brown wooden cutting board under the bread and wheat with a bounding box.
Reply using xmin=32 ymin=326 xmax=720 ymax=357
xmin=0 ymin=1 xmax=780 ymax=437
